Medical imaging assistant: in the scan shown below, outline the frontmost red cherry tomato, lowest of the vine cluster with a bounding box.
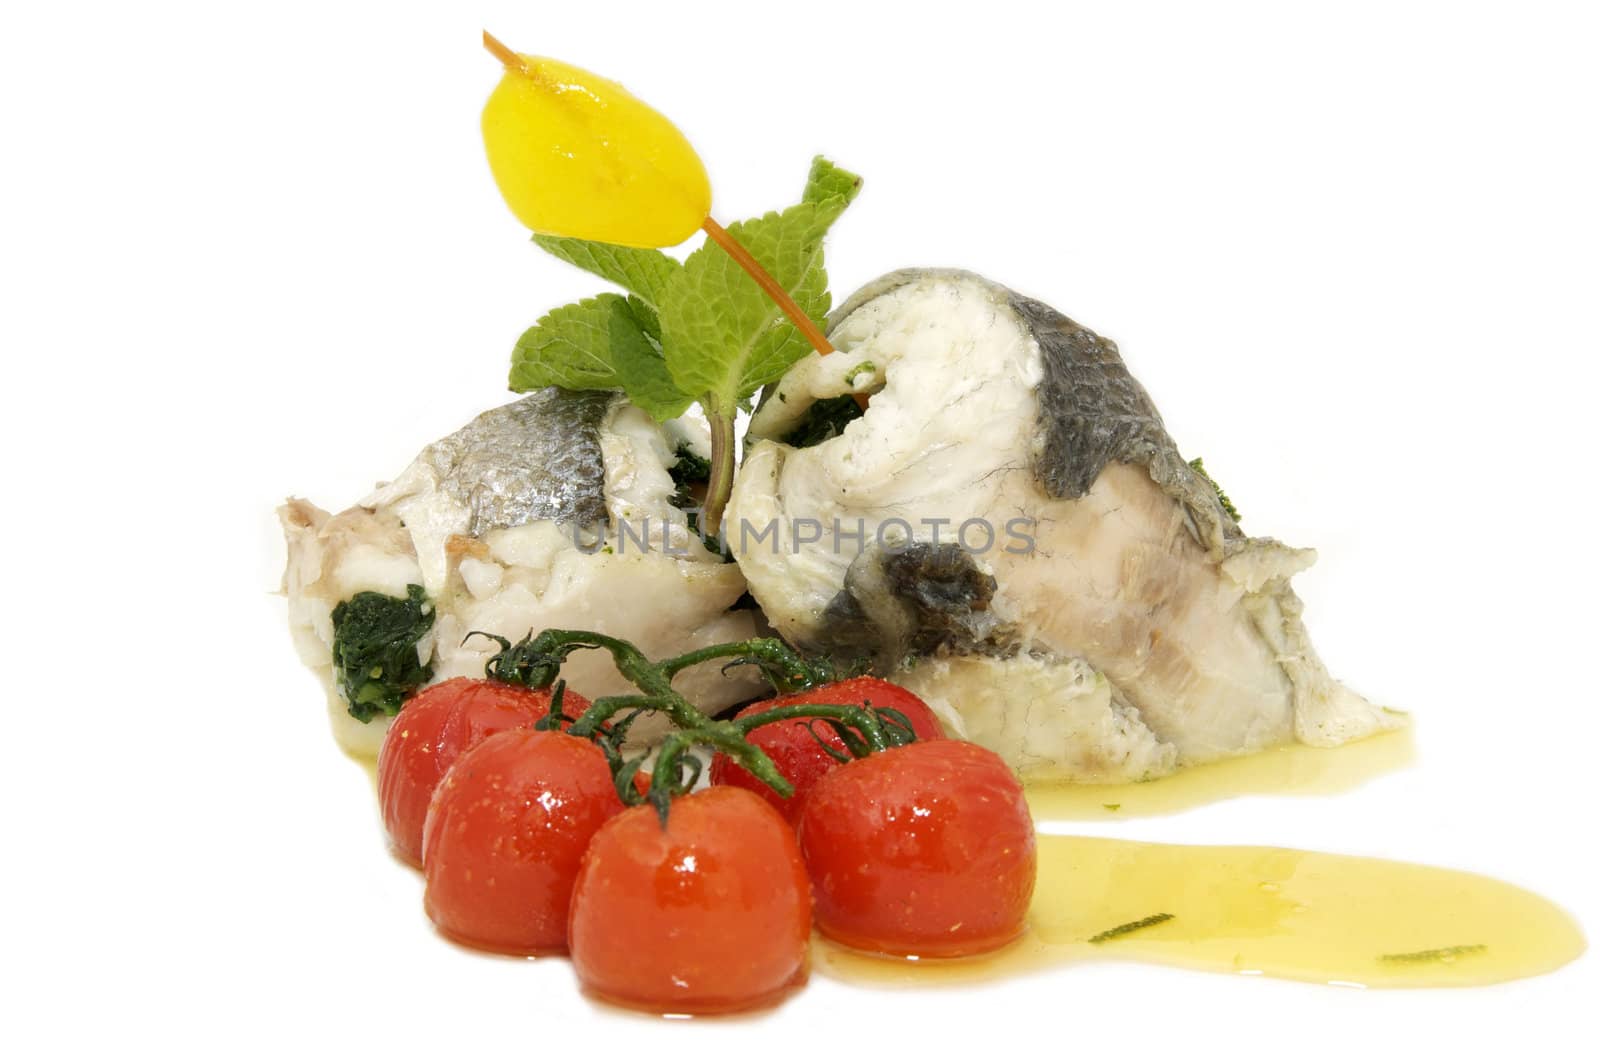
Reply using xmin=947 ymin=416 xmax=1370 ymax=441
xmin=568 ymin=786 xmax=811 ymax=1013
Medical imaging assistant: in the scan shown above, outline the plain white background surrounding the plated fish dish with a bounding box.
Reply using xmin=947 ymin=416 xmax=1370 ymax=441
xmin=0 ymin=0 xmax=1600 ymax=1060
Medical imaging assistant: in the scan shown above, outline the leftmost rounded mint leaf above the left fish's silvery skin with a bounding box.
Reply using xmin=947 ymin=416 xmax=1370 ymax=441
xmin=510 ymin=293 xmax=636 ymax=391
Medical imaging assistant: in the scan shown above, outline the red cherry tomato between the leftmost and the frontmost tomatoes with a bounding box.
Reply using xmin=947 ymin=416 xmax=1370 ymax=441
xmin=422 ymin=730 xmax=624 ymax=954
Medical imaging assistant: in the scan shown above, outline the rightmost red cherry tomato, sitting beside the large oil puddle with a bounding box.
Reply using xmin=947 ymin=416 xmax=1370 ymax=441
xmin=798 ymin=741 xmax=1035 ymax=956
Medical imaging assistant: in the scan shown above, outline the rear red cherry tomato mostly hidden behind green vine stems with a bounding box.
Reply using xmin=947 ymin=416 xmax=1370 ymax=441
xmin=710 ymin=676 xmax=944 ymax=824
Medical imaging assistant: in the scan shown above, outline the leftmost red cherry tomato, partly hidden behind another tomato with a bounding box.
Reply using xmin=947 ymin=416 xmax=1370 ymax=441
xmin=378 ymin=677 xmax=589 ymax=868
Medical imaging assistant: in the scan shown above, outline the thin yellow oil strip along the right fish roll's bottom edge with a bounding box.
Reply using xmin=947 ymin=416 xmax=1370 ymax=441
xmin=1027 ymin=727 xmax=1416 ymax=820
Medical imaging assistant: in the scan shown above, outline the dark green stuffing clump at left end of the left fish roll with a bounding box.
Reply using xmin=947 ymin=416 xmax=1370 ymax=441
xmin=333 ymin=584 xmax=434 ymax=724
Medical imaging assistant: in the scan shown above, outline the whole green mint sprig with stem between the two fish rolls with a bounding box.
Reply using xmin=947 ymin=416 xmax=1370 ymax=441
xmin=510 ymin=155 xmax=861 ymax=532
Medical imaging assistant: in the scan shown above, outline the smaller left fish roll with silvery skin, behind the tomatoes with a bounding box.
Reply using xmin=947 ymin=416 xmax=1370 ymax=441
xmin=278 ymin=387 xmax=765 ymax=756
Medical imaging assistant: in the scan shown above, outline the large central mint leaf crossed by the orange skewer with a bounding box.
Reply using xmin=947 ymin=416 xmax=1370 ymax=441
xmin=659 ymin=188 xmax=850 ymax=413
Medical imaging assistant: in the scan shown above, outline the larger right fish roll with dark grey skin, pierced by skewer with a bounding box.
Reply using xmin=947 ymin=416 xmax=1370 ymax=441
xmin=725 ymin=271 xmax=1403 ymax=781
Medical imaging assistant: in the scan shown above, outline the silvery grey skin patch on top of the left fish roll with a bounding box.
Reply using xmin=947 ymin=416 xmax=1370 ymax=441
xmin=418 ymin=387 xmax=618 ymax=538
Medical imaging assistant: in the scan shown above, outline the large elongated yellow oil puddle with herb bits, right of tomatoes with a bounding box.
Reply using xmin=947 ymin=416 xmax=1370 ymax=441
xmin=813 ymin=834 xmax=1584 ymax=988
